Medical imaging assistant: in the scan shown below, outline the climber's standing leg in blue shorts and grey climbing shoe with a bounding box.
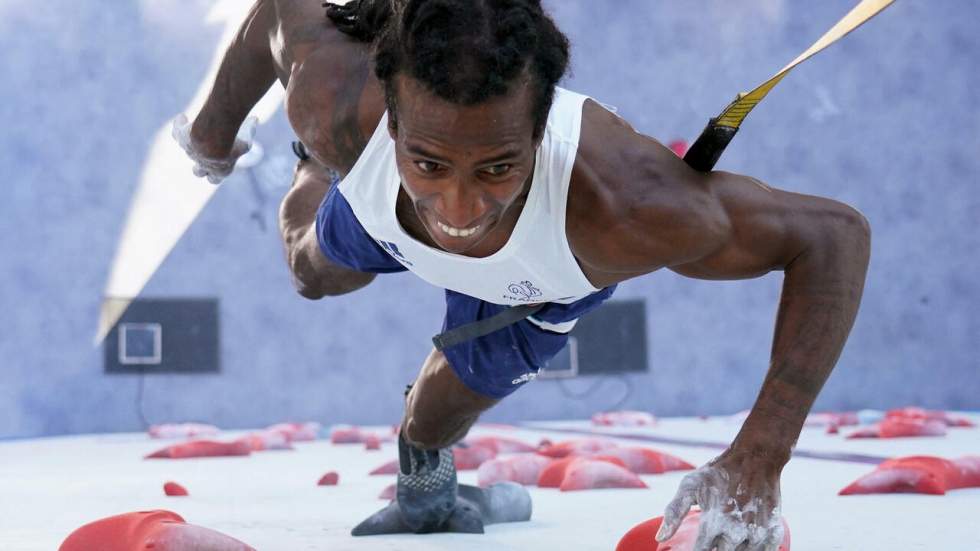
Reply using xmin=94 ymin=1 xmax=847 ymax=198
xmin=353 ymin=288 xmax=612 ymax=536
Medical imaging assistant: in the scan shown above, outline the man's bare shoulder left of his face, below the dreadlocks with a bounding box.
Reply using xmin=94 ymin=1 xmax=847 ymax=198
xmin=272 ymin=0 xmax=384 ymax=173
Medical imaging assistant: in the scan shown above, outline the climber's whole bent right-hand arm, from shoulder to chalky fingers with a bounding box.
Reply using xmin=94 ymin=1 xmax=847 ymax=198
xmin=568 ymin=104 xmax=870 ymax=551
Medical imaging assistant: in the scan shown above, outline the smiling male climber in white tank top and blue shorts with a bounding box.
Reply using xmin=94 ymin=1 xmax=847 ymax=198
xmin=174 ymin=0 xmax=870 ymax=551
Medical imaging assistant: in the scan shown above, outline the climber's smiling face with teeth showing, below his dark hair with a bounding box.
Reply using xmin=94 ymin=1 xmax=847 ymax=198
xmin=392 ymin=77 xmax=537 ymax=254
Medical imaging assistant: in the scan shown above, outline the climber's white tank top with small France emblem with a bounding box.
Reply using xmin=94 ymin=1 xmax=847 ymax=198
xmin=339 ymin=88 xmax=598 ymax=305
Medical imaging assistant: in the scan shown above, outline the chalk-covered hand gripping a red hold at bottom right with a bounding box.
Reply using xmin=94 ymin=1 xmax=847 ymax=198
xmin=657 ymin=449 xmax=784 ymax=551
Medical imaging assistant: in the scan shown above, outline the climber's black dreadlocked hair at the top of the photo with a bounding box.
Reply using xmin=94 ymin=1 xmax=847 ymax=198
xmin=324 ymin=0 xmax=569 ymax=138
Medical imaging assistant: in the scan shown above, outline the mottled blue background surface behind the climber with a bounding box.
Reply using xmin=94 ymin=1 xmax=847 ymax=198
xmin=0 ymin=0 xmax=980 ymax=436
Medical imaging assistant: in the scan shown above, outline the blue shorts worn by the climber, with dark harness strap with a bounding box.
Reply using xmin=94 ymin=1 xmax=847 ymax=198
xmin=316 ymin=182 xmax=616 ymax=399
